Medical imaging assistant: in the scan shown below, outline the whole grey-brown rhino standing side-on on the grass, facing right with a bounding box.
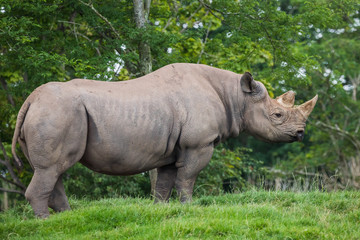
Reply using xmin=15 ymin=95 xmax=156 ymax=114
xmin=12 ymin=64 xmax=316 ymax=217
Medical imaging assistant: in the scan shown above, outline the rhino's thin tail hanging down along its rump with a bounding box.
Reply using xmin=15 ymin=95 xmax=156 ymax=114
xmin=11 ymin=101 xmax=30 ymax=170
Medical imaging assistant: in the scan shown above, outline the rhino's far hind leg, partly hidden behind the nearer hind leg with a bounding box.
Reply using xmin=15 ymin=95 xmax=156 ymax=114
xmin=48 ymin=175 xmax=71 ymax=212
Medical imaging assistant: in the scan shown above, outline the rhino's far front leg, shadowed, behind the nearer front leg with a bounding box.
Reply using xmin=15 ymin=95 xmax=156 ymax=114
xmin=155 ymin=164 xmax=177 ymax=203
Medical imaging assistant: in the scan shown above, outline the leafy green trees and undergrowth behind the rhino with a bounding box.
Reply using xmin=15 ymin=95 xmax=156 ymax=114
xmin=0 ymin=0 xmax=360 ymax=209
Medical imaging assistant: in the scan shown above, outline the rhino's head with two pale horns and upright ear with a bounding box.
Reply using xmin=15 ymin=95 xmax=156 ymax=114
xmin=240 ymin=72 xmax=318 ymax=142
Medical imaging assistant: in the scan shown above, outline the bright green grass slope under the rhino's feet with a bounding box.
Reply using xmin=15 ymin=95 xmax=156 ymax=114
xmin=0 ymin=191 xmax=360 ymax=239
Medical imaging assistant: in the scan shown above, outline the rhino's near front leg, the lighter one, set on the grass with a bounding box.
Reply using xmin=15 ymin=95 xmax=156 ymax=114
xmin=175 ymin=144 xmax=214 ymax=203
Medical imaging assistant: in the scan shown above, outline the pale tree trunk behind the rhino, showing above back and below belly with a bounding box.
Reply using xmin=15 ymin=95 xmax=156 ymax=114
xmin=133 ymin=0 xmax=157 ymax=196
